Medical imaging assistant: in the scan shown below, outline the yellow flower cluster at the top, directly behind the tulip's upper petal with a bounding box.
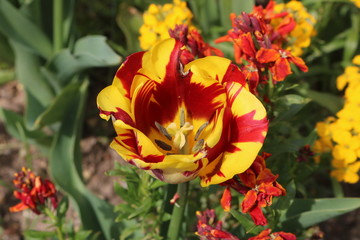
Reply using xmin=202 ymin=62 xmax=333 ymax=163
xmin=139 ymin=0 xmax=193 ymax=50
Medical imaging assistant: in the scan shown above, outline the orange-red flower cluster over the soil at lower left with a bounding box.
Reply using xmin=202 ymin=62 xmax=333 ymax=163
xmin=9 ymin=168 xmax=57 ymax=214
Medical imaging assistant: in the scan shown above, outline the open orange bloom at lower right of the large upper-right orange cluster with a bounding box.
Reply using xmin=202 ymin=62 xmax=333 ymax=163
xmin=256 ymin=48 xmax=308 ymax=81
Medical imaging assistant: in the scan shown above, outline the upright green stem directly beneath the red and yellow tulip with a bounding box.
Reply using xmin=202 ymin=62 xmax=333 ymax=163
xmin=167 ymin=182 xmax=189 ymax=240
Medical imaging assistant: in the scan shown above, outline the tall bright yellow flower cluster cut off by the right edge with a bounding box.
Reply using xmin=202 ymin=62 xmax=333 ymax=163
xmin=314 ymin=55 xmax=360 ymax=183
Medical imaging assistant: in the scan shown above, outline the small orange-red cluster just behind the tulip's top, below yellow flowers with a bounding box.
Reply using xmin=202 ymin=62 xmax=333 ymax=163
xmin=169 ymin=24 xmax=224 ymax=65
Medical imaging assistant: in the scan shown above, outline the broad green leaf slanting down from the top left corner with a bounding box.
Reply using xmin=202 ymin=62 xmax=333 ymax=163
xmin=0 ymin=0 xmax=52 ymax=59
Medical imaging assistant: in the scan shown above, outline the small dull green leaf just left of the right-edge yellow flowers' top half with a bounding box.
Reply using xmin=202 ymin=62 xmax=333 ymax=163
xmin=306 ymin=90 xmax=343 ymax=114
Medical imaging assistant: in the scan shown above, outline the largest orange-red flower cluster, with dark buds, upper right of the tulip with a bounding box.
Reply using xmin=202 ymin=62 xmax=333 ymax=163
xmin=215 ymin=1 xmax=308 ymax=93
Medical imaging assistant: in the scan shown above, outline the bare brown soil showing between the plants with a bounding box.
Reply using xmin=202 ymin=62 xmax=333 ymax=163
xmin=0 ymin=81 xmax=360 ymax=240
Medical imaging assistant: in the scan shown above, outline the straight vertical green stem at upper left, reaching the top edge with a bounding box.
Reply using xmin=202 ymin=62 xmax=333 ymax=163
xmin=53 ymin=0 xmax=63 ymax=53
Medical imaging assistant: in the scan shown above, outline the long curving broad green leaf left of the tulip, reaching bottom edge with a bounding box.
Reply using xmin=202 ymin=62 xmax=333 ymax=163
xmin=49 ymin=81 xmax=119 ymax=239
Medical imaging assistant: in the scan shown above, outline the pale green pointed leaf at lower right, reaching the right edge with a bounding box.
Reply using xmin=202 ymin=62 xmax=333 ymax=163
xmin=280 ymin=198 xmax=360 ymax=232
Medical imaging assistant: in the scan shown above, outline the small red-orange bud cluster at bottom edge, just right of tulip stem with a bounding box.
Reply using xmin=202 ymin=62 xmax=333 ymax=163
xmin=196 ymin=209 xmax=240 ymax=240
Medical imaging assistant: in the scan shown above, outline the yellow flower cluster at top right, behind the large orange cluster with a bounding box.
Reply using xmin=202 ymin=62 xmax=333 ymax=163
xmin=274 ymin=0 xmax=316 ymax=56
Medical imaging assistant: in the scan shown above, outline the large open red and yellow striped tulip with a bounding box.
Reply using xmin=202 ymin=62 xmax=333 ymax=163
xmin=97 ymin=39 xmax=268 ymax=186
